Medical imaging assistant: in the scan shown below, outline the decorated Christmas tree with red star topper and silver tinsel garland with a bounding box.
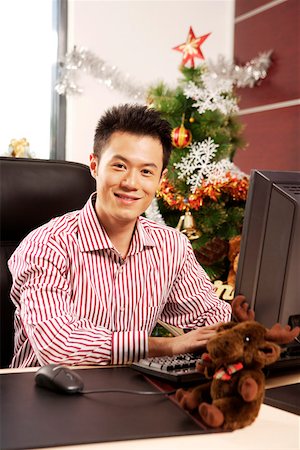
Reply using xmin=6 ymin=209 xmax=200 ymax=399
xmin=55 ymin=27 xmax=272 ymax=284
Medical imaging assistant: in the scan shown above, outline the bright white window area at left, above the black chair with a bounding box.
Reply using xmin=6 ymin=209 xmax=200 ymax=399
xmin=0 ymin=0 xmax=53 ymax=159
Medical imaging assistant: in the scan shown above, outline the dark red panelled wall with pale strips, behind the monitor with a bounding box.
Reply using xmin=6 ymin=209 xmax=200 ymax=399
xmin=234 ymin=0 xmax=300 ymax=173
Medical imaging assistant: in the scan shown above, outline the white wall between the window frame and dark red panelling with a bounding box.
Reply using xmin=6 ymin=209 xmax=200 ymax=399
xmin=66 ymin=0 xmax=234 ymax=164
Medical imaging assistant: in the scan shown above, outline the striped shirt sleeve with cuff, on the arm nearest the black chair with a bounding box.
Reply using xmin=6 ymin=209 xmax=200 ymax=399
xmin=9 ymin=239 xmax=147 ymax=365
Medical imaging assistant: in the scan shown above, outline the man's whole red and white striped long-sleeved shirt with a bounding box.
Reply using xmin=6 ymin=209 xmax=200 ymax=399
xmin=9 ymin=193 xmax=231 ymax=367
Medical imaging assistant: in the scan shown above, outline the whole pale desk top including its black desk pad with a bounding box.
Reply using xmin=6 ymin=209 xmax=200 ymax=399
xmin=0 ymin=368 xmax=300 ymax=450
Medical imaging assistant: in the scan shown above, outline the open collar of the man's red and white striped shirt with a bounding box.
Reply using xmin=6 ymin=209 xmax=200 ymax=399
xmin=78 ymin=192 xmax=156 ymax=255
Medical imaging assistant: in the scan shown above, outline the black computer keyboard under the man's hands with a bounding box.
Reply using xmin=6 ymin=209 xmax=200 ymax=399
xmin=131 ymin=353 xmax=205 ymax=383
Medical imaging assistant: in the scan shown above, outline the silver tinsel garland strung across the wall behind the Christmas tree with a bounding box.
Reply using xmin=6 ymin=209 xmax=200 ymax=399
xmin=55 ymin=47 xmax=272 ymax=97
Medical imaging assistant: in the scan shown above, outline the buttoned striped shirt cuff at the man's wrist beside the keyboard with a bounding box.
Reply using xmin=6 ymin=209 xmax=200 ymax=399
xmin=111 ymin=331 xmax=148 ymax=364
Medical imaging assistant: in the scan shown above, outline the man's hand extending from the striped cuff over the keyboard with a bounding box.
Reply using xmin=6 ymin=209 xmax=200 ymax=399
xmin=148 ymin=323 xmax=221 ymax=358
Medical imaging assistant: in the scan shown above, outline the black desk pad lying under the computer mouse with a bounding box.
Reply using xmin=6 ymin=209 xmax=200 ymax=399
xmin=0 ymin=367 xmax=216 ymax=449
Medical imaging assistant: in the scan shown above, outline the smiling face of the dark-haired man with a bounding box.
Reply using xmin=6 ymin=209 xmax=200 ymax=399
xmin=90 ymin=132 xmax=165 ymax=228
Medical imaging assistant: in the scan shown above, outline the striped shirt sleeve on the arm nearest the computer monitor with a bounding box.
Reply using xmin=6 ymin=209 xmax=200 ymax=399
xmin=161 ymin=238 xmax=231 ymax=329
